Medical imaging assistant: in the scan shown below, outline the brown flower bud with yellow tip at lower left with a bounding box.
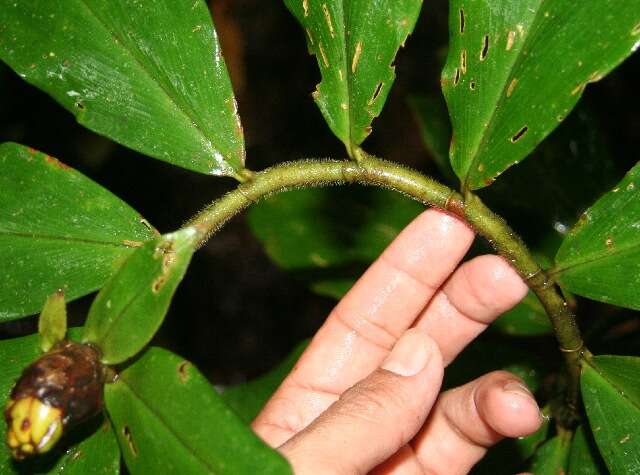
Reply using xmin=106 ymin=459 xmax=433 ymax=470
xmin=5 ymin=341 xmax=105 ymax=459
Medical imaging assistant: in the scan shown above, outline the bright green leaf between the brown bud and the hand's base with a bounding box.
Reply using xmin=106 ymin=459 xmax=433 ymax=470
xmin=105 ymin=348 xmax=292 ymax=475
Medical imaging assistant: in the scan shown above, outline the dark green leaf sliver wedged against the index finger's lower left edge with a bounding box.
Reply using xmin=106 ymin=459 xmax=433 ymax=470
xmin=222 ymin=340 xmax=309 ymax=423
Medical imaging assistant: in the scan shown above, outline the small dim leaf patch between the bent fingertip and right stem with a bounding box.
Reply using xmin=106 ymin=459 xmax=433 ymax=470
xmin=491 ymin=291 xmax=552 ymax=336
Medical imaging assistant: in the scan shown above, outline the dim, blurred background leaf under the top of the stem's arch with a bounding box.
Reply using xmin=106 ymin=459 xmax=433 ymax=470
xmin=249 ymin=188 xmax=424 ymax=270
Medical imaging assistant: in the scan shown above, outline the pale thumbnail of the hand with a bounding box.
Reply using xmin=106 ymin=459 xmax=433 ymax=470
xmin=381 ymin=330 xmax=432 ymax=376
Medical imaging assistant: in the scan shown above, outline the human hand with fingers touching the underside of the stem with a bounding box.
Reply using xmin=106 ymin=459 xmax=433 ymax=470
xmin=253 ymin=209 xmax=542 ymax=475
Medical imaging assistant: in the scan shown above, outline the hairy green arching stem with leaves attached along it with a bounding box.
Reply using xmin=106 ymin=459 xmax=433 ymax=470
xmin=186 ymin=152 xmax=583 ymax=420
